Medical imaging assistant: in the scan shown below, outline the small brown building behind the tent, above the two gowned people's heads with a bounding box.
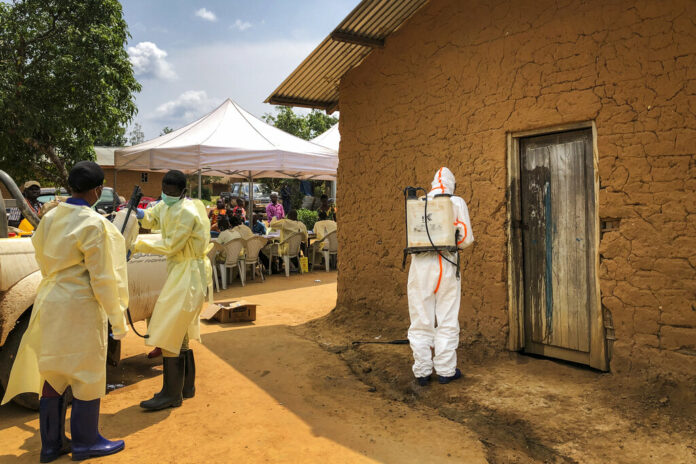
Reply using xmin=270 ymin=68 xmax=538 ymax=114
xmin=94 ymin=147 xmax=165 ymax=200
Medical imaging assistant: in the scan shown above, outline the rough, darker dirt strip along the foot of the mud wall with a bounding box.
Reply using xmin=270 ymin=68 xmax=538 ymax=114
xmin=298 ymin=310 xmax=696 ymax=464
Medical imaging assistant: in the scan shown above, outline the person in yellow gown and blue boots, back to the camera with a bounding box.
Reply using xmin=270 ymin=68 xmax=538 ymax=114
xmin=3 ymin=161 xmax=128 ymax=462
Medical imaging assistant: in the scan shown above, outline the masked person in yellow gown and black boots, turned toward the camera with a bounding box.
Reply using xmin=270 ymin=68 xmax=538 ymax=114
xmin=133 ymin=170 xmax=213 ymax=411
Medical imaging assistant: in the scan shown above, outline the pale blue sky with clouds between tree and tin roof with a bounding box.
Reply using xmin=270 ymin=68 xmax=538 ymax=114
xmin=121 ymin=0 xmax=359 ymax=139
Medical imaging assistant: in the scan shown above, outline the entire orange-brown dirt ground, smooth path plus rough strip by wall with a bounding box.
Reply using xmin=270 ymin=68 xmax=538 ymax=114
xmin=0 ymin=272 xmax=696 ymax=464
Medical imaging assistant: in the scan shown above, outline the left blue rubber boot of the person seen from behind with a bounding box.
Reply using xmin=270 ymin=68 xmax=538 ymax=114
xmin=39 ymin=396 xmax=70 ymax=462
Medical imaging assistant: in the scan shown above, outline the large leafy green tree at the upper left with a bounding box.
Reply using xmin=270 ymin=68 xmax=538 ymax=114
xmin=0 ymin=0 xmax=140 ymax=185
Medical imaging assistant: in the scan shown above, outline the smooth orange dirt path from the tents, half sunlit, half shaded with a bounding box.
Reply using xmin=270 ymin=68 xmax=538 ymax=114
xmin=0 ymin=272 xmax=486 ymax=463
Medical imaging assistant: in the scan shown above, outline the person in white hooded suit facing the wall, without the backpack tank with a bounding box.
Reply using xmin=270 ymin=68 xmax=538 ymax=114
xmin=408 ymin=167 xmax=474 ymax=386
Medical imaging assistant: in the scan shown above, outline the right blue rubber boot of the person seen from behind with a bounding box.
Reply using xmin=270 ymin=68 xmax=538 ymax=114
xmin=70 ymin=398 xmax=125 ymax=461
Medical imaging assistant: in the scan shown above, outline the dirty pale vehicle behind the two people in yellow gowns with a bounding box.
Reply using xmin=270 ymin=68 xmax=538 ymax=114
xmin=0 ymin=171 xmax=167 ymax=409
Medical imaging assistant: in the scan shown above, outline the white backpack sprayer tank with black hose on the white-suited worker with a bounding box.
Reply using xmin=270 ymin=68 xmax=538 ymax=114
xmin=401 ymin=187 xmax=459 ymax=279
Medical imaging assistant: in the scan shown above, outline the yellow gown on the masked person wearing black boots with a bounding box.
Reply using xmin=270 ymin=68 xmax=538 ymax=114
xmin=133 ymin=199 xmax=213 ymax=353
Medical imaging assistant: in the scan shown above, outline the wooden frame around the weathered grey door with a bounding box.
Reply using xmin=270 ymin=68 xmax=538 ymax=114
xmin=506 ymin=121 xmax=609 ymax=371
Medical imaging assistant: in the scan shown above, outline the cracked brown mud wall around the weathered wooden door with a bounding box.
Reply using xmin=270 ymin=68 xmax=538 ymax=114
xmin=337 ymin=0 xmax=696 ymax=374
